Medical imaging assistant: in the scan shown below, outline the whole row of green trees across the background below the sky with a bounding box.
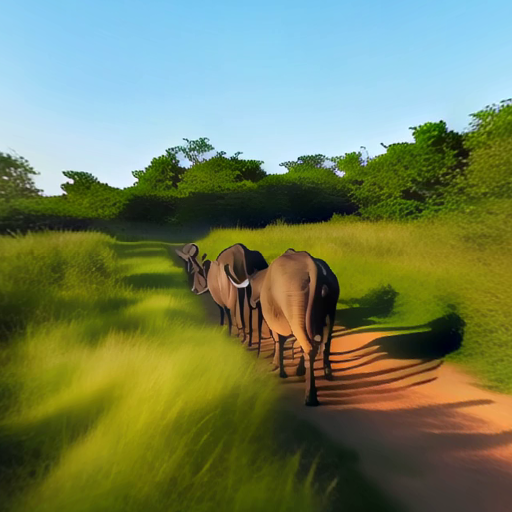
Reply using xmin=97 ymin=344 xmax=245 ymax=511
xmin=0 ymin=96 xmax=512 ymax=231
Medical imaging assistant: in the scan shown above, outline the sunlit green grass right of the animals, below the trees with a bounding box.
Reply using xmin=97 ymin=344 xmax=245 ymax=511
xmin=196 ymin=202 xmax=512 ymax=392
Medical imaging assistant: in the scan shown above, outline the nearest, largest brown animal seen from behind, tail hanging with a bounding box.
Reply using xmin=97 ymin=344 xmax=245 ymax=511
xmin=226 ymin=249 xmax=339 ymax=405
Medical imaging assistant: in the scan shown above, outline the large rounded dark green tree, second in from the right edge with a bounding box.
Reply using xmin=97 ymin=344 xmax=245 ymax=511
xmin=333 ymin=121 xmax=467 ymax=219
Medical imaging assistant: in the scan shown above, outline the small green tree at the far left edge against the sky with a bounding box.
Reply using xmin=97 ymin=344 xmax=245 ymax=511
xmin=0 ymin=152 xmax=42 ymax=202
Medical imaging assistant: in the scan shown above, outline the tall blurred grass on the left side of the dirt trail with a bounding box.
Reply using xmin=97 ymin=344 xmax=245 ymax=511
xmin=0 ymin=230 xmax=396 ymax=512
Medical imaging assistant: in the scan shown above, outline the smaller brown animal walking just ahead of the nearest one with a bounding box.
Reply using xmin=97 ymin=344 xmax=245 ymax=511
xmin=190 ymin=244 xmax=268 ymax=346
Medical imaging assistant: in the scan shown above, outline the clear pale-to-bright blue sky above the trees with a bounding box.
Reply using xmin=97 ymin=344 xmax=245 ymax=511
xmin=0 ymin=0 xmax=512 ymax=194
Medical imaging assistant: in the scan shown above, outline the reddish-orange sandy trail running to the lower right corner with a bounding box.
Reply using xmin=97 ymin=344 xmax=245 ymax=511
xmin=255 ymin=328 xmax=512 ymax=512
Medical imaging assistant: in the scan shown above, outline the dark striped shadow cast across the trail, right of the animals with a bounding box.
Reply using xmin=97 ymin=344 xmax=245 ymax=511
xmin=251 ymin=306 xmax=465 ymax=406
